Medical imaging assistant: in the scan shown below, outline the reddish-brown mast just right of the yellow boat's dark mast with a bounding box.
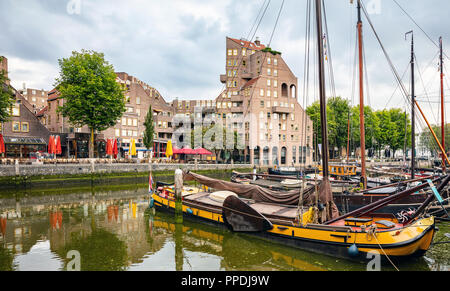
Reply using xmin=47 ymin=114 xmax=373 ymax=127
xmin=357 ymin=0 xmax=367 ymax=189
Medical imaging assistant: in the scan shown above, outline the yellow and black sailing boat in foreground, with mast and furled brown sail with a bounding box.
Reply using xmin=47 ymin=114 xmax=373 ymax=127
xmin=152 ymin=0 xmax=450 ymax=259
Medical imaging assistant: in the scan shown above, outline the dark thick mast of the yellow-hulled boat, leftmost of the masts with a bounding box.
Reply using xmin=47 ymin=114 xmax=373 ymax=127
xmin=316 ymin=0 xmax=329 ymax=180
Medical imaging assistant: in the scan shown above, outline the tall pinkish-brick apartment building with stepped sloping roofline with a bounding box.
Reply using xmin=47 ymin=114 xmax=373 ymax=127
xmin=215 ymin=37 xmax=313 ymax=166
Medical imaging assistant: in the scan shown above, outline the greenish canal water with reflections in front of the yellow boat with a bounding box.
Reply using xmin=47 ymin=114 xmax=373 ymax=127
xmin=0 ymin=185 xmax=450 ymax=271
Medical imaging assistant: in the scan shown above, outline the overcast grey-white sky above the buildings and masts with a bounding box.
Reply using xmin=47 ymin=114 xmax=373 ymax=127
xmin=0 ymin=0 xmax=450 ymax=123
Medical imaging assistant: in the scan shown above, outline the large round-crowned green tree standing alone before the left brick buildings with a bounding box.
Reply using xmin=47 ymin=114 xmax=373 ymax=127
xmin=56 ymin=50 xmax=125 ymax=158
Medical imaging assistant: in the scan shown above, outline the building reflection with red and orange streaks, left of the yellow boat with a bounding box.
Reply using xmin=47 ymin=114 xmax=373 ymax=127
xmin=0 ymin=189 xmax=158 ymax=270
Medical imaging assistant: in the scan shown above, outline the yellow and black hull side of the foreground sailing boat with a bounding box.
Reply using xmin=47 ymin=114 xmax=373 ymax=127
xmin=153 ymin=194 xmax=435 ymax=261
